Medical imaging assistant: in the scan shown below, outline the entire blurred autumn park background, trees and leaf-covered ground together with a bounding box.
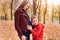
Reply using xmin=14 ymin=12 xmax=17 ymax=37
xmin=0 ymin=0 xmax=60 ymax=40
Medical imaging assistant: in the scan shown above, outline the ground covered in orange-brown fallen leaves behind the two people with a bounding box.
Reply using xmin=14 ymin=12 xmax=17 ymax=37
xmin=0 ymin=21 xmax=60 ymax=40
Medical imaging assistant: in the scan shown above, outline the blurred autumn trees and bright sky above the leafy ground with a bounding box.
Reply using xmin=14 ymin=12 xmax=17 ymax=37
xmin=0 ymin=0 xmax=60 ymax=24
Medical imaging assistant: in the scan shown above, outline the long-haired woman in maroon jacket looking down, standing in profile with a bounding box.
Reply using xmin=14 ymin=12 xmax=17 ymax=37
xmin=14 ymin=0 xmax=32 ymax=40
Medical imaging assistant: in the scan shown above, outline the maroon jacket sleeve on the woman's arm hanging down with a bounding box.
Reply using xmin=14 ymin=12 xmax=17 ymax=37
xmin=14 ymin=10 xmax=23 ymax=37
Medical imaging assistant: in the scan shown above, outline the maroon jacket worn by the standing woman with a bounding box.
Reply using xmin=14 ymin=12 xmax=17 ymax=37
xmin=14 ymin=8 xmax=28 ymax=37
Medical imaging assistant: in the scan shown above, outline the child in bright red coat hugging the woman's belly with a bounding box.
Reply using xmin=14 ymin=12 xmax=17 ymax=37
xmin=27 ymin=16 xmax=44 ymax=40
